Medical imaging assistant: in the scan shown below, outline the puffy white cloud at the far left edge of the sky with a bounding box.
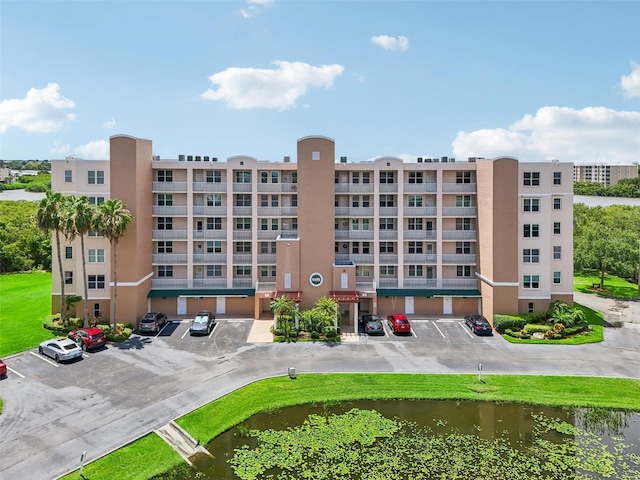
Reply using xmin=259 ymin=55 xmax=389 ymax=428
xmin=0 ymin=83 xmax=76 ymax=133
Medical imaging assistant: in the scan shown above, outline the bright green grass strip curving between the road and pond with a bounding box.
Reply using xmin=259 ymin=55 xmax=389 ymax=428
xmin=63 ymin=373 xmax=640 ymax=480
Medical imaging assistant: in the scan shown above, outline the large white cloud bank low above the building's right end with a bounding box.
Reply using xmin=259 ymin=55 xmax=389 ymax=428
xmin=453 ymin=107 xmax=640 ymax=163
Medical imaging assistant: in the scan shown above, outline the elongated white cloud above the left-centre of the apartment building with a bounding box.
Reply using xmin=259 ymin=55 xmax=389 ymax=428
xmin=202 ymin=61 xmax=344 ymax=110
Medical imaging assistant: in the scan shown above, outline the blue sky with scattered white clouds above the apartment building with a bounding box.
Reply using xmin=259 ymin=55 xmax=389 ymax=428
xmin=0 ymin=0 xmax=640 ymax=163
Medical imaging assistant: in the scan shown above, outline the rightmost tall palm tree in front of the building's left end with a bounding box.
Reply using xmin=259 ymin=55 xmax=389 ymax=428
xmin=95 ymin=198 xmax=133 ymax=330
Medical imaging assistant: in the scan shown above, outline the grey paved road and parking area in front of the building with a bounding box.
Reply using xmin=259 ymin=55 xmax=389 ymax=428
xmin=0 ymin=301 xmax=640 ymax=480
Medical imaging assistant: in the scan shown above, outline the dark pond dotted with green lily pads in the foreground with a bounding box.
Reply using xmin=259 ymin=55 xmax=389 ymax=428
xmin=171 ymin=400 xmax=640 ymax=480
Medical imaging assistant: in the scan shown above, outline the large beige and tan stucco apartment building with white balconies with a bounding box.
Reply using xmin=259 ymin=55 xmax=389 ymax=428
xmin=47 ymin=135 xmax=573 ymax=328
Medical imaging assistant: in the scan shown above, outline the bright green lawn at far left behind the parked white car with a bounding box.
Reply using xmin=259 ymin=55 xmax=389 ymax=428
xmin=0 ymin=272 xmax=53 ymax=357
